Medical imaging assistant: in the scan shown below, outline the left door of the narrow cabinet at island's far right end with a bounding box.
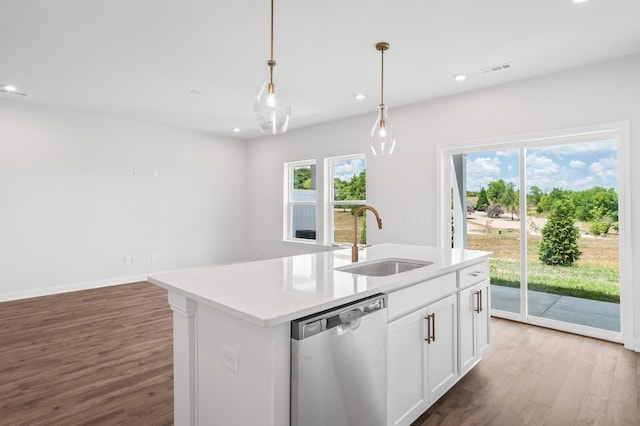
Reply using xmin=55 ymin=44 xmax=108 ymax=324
xmin=458 ymin=286 xmax=478 ymax=374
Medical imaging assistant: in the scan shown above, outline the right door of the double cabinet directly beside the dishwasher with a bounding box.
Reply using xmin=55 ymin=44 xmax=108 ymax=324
xmin=427 ymin=294 xmax=458 ymax=403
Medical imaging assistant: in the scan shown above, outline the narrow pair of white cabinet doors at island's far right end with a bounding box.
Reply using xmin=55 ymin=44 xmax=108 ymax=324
xmin=458 ymin=279 xmax=491 ymax=375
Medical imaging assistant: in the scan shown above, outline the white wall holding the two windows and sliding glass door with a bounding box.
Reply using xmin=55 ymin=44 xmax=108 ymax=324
xmin=248 ymin=55 xmax=640 ymax=347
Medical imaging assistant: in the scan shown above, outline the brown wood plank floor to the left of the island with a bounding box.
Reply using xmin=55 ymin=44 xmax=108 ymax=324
xmin=0 ymin=282 xmax=173 ymax=426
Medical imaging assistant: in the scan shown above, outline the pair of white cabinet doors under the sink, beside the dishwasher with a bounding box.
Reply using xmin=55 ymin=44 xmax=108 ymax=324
xmin=388 ymin=294 xmax=458 ymax=425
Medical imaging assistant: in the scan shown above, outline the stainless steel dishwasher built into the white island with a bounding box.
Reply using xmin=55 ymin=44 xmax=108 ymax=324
xmin=291 ymin=294 xmax=387 ymax=426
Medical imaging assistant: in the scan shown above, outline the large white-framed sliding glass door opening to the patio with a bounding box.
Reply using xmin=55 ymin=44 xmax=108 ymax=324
xmin=442 ymin=124 xmax=628 ymax=341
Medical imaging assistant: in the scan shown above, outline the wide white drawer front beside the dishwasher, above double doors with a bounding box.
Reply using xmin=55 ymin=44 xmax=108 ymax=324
xmin=388 ymin=272 xmax=457 ymax=321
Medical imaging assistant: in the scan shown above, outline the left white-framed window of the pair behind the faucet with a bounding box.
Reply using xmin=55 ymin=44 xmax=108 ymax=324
xmin=284 ymin=160 xmax=317 ymax=241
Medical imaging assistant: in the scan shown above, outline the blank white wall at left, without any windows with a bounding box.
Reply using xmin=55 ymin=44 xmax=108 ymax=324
xmin=0 ymin=101 xmax=247 ymax=300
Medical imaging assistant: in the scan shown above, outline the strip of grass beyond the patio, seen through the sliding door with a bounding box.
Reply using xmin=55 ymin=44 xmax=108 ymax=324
xmin=489 ymin=258 xmax=620 ymax=303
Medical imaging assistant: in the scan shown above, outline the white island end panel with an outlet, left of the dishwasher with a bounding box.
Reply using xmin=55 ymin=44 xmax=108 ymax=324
xmin=196 ymin=304 xmax=291 ymax=426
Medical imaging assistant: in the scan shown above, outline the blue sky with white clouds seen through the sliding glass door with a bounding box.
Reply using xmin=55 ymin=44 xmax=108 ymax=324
xmin=467 ymin=141 xmax=618 ymax=193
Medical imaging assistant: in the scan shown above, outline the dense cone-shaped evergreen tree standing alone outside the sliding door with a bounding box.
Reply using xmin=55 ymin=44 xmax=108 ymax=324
xmin=538 ymin=197 xmax=582 ymax=266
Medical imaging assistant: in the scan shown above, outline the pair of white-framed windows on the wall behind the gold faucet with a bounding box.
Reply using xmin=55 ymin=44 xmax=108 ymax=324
xmin=283 ymin=154 xmax=367 ymax=245
